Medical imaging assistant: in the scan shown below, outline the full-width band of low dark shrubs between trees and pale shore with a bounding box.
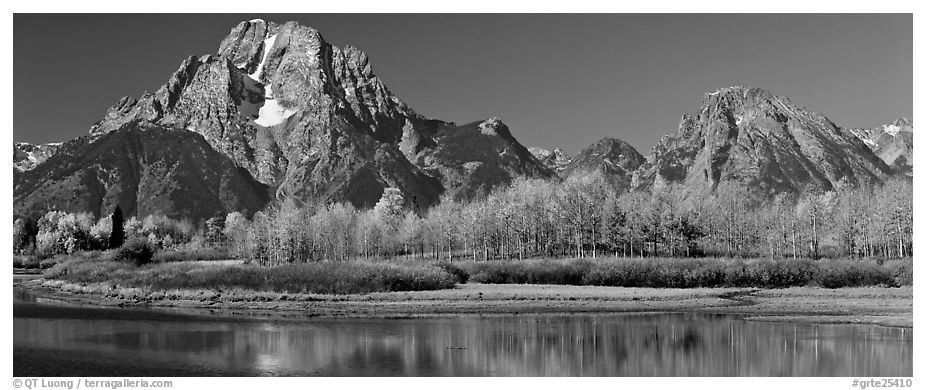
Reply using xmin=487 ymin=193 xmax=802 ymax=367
xmin=43 ymin=253 xmax=913 ymax=294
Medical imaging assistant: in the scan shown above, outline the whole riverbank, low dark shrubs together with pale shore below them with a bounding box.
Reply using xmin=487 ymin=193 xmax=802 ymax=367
xmin=19 ymin=253 xmax=913 ymax=326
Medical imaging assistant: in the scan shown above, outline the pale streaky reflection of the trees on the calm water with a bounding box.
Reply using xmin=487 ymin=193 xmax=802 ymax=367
xmin=219 ymin=314 xmax=912 ymax=376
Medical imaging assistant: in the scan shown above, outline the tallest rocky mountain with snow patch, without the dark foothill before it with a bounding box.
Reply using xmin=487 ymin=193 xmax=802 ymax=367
xmin=16 ymin=19 xmax=554 ymax=219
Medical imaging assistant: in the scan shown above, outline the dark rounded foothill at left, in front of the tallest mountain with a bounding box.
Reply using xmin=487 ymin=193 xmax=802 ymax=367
xmin=13 ymin=122 xmax=268 ymax=221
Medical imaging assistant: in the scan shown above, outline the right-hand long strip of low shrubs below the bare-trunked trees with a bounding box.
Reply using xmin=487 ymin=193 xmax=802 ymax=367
xmin=448 ymin=258 xmax=913 ymax=288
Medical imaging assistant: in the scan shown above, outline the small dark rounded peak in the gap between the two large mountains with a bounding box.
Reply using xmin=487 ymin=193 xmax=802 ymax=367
xmin=561 ymin=137 xmax=646 ymax=192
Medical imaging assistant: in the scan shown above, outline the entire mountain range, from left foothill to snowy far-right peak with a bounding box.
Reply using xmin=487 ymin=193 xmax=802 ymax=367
xmin=14 ymin=19 xmax=912 ymax=220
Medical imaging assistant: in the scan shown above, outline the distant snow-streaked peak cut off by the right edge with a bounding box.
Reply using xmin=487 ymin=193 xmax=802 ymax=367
xmin=849 ymin=118 xmax=913 ymax=175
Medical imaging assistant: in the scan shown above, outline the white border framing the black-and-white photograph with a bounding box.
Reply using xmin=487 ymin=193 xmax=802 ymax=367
xmin=0 ymin=0 xmax=926 ymax=390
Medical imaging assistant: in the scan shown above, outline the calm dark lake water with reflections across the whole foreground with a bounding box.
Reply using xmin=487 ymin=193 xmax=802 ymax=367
xmin=14 ymin=288 xmax=913 ymax=376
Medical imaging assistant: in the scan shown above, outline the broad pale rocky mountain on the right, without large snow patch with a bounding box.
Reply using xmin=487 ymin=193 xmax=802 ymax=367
xmin=633 ymin=87 xmax=891 ymax=196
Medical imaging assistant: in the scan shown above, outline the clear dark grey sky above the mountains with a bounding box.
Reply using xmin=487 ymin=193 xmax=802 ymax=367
xmin=13 ymin=14 xmax=913 ymax=154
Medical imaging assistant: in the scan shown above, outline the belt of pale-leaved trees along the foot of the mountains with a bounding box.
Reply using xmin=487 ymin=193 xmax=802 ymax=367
xmin=13 ymin=176 xmax=913 ymax=265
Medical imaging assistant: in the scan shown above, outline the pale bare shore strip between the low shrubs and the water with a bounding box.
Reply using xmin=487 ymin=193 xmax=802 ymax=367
xmin=14 ymin=275 xmax=913 ymax=328
